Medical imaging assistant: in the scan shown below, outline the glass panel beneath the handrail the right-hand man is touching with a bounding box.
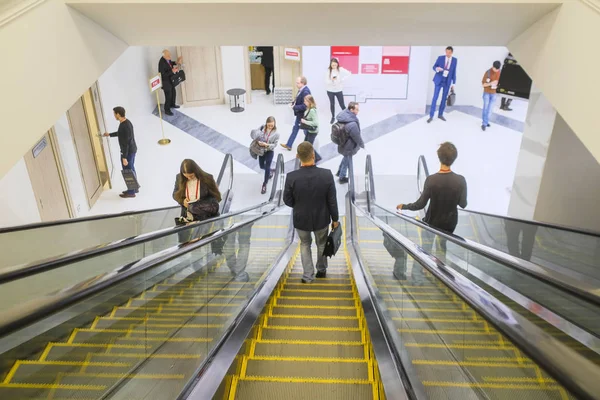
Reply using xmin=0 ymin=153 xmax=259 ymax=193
xmin=378 ymin=214 xmax=600 ymax=355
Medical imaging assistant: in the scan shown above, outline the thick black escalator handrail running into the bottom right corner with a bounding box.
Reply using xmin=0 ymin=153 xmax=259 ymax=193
xmin=354 ymin=195 xmax=600 ymax=399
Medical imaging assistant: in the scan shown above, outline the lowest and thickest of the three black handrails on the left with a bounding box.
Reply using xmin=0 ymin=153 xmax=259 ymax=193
xmin=0 ymin=203 xmax=280 ymax=337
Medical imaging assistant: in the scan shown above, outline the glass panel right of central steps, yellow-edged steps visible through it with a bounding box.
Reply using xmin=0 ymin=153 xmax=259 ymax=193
xmin=357 ymin=211 xmax=584 ymax=399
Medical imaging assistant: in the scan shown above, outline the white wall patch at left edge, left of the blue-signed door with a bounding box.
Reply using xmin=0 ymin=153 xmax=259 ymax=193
xmin=0 ymin=158 xmax=42 ymax=228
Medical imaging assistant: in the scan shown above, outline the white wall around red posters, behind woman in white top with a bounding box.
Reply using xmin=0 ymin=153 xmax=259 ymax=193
xmin=302 ymin=46 xmax=431 ymax=113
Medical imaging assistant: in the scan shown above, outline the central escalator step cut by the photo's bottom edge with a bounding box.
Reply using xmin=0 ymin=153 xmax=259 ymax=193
xmin=236 ymin=379 xmax=373 ymax=400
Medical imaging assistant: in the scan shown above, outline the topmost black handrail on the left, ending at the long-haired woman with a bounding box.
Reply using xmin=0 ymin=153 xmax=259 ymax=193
xmin=0 ymin=153 xmax=233 ymax=235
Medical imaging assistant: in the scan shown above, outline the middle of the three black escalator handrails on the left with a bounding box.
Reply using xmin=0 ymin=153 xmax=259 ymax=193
xmin=0 ymin=154 xmax=284 ymax=285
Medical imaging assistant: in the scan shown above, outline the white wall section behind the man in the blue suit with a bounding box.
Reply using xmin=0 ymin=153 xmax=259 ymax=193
xmin=427 ymin=46 xmax=508 ymax=107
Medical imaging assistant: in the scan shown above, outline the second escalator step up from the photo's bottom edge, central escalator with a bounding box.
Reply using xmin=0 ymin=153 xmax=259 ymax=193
xmin=246 ymin=358 xmax=369 ymax=380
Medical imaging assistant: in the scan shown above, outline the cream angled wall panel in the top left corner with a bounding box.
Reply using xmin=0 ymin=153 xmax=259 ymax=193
xmin=0 ymin=0 xmax=127 ymax=177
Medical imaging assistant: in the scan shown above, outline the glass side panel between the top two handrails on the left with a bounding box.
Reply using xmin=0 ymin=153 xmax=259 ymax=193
xmin=0 ymin=154 xmax=234 ymax=270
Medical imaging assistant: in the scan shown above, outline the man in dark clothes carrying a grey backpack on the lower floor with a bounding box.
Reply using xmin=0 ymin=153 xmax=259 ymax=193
xmin=331 ymin=101 xmax=365 ymax=184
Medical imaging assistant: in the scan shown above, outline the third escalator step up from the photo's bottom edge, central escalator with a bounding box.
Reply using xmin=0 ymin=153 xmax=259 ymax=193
xmin=254 ymin=341 xmax=365 ymax=359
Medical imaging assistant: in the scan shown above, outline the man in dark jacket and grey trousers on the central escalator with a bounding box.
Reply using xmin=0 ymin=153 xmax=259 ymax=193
xmin=283 ymin=142 xmax=339 ymax=283
